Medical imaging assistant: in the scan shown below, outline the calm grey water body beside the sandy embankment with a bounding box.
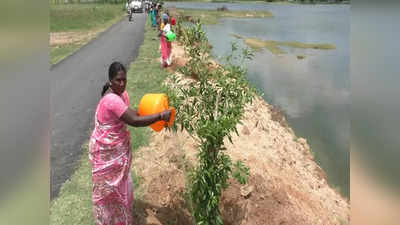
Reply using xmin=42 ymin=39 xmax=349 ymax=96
xmin=167 ymin=2 xmax=350 ymax=197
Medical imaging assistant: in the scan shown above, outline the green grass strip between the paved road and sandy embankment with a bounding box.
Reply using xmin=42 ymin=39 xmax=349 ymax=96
xmin=50 ymin=20 xmax=167 ymax=225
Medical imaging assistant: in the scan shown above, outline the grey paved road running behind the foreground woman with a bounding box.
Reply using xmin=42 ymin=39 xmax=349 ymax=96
xmin=50 ymin=13 xmax=146 ymax=199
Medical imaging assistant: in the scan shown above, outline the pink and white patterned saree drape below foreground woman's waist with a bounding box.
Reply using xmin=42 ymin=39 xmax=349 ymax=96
xmin=89 ymin=115 xmax=133 ymax=225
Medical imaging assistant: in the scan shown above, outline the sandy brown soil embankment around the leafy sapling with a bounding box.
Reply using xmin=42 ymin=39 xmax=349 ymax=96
xmin=132 ymin=41 xmax=350 ymax=225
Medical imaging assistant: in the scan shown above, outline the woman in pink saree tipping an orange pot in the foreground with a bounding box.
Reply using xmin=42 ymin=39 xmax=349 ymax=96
xmin=89 ymin=62 xmax=171 ymax=225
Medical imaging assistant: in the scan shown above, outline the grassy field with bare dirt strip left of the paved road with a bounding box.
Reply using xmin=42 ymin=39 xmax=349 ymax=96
xmin=50 ymin=3 xmax=125 ymax=64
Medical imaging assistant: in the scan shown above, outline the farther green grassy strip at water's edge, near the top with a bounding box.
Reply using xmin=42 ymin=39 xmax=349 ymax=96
xmin=176 ymin=9 xmax=273 ymax=24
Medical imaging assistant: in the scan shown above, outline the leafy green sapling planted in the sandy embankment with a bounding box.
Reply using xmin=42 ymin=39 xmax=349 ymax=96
xmin=168 ymin=22 xmax=255 ymax=225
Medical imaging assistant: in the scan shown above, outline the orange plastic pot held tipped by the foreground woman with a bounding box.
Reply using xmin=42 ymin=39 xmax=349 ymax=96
xmin=138 ymin=94 xmax=176 ymax=132
